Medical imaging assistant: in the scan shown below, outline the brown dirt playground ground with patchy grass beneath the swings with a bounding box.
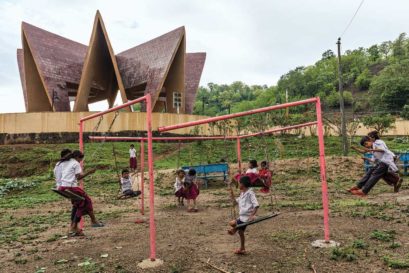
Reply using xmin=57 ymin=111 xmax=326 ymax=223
xmin=0 ymin=158 xmax=409 ymax=273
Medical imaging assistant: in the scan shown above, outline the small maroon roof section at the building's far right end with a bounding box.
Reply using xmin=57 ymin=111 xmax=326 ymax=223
xmin=185 ymin=52 xmax=206 ymax=114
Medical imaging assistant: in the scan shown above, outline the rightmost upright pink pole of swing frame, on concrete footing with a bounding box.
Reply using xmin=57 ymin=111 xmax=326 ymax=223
xmin=315 ymin=98 xmax=329 ymax=242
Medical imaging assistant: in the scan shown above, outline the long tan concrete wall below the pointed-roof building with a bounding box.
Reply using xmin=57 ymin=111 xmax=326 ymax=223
xmin=0 ymin=112 xmax=208 ymax=134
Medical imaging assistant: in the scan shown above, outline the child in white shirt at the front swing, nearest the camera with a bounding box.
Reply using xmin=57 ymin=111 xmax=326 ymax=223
xmin=228 ymin=176 xmax=259 ymax=254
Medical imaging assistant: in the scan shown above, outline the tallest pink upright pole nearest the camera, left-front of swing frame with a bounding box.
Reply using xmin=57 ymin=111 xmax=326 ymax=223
xmin=146 ymin=95 xmax=156 ymax=261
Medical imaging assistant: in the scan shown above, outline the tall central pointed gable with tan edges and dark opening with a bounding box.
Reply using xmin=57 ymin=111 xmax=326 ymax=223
xmin=74 ymin=11 xmax=130 ymax=111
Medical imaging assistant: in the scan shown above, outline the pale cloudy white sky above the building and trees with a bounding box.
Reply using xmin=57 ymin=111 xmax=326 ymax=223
xmin=0 ymin=0 xmax=409 ymax=113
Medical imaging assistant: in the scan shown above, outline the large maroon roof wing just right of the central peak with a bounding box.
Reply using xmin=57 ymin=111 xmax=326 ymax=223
xmin=117 ymin=27 xmax=185 ymax=108
